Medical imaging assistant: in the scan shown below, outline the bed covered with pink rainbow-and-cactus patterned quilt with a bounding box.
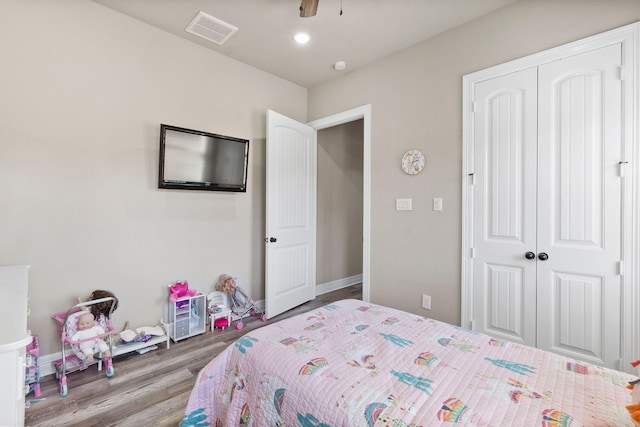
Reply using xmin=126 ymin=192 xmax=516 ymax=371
xmin=181 ymin=300 xmax=637 ymax=427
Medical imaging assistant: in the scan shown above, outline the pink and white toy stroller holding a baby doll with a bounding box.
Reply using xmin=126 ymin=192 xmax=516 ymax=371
xmin=53 ymin=297 xmax=117 ymax=397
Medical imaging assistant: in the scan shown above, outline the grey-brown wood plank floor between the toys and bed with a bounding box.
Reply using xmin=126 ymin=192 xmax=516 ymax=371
xmin=25 ymin=285 xmax=362 ymax=427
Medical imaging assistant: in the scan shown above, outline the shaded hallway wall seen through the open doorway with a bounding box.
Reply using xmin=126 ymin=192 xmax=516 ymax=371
xmin=316 ymin=120 xmax=364 ymax=285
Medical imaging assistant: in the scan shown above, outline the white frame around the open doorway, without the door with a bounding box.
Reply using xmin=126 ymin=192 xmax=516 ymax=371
xmin=307 ymin=104 xmax=371 ymax=302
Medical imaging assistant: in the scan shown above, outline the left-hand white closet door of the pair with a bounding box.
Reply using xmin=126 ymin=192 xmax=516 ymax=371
xmin=470 ymin=68 xmax=537 ymax=346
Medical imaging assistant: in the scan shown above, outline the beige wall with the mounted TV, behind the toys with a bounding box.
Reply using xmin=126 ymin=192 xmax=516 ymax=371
xmin=0 ymin=0 xmax=307 ymax=354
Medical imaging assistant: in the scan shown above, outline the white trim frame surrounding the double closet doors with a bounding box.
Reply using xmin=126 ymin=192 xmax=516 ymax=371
xmin=460 ymin=23 xmax=640 ymax=372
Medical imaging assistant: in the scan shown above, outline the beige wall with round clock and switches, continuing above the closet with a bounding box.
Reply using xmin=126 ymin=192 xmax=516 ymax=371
xmin=309 ymin=0 xmax=640 ymax=324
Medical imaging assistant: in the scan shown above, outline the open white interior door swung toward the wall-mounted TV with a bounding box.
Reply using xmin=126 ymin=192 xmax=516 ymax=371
xmin=265 ymin=110 xmax=317 ymax=318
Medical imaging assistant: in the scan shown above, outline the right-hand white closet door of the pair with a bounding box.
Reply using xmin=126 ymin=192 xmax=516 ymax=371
xmin=537 ymin=44 xmax=622 ymax=368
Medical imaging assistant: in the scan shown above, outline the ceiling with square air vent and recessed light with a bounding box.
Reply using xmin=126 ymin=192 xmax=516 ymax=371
xmin=93 ymin=0 xmax=519 ymax=87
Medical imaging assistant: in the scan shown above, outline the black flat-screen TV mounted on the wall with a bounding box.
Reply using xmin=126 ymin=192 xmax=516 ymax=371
xmin=158 ymin=124 xmax=249 ymax=192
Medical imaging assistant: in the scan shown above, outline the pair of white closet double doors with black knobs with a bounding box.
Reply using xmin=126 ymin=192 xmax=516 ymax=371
xmin=471 ymin=45 xmax=622 ymax=367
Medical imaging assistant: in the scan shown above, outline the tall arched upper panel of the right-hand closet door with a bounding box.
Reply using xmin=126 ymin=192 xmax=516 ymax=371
xmin=550 ymin=70 xmax=605 ymax=244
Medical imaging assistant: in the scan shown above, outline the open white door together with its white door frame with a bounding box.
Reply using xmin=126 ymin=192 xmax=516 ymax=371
xmin=265 ymin=105 xmax=371 ymax=317
